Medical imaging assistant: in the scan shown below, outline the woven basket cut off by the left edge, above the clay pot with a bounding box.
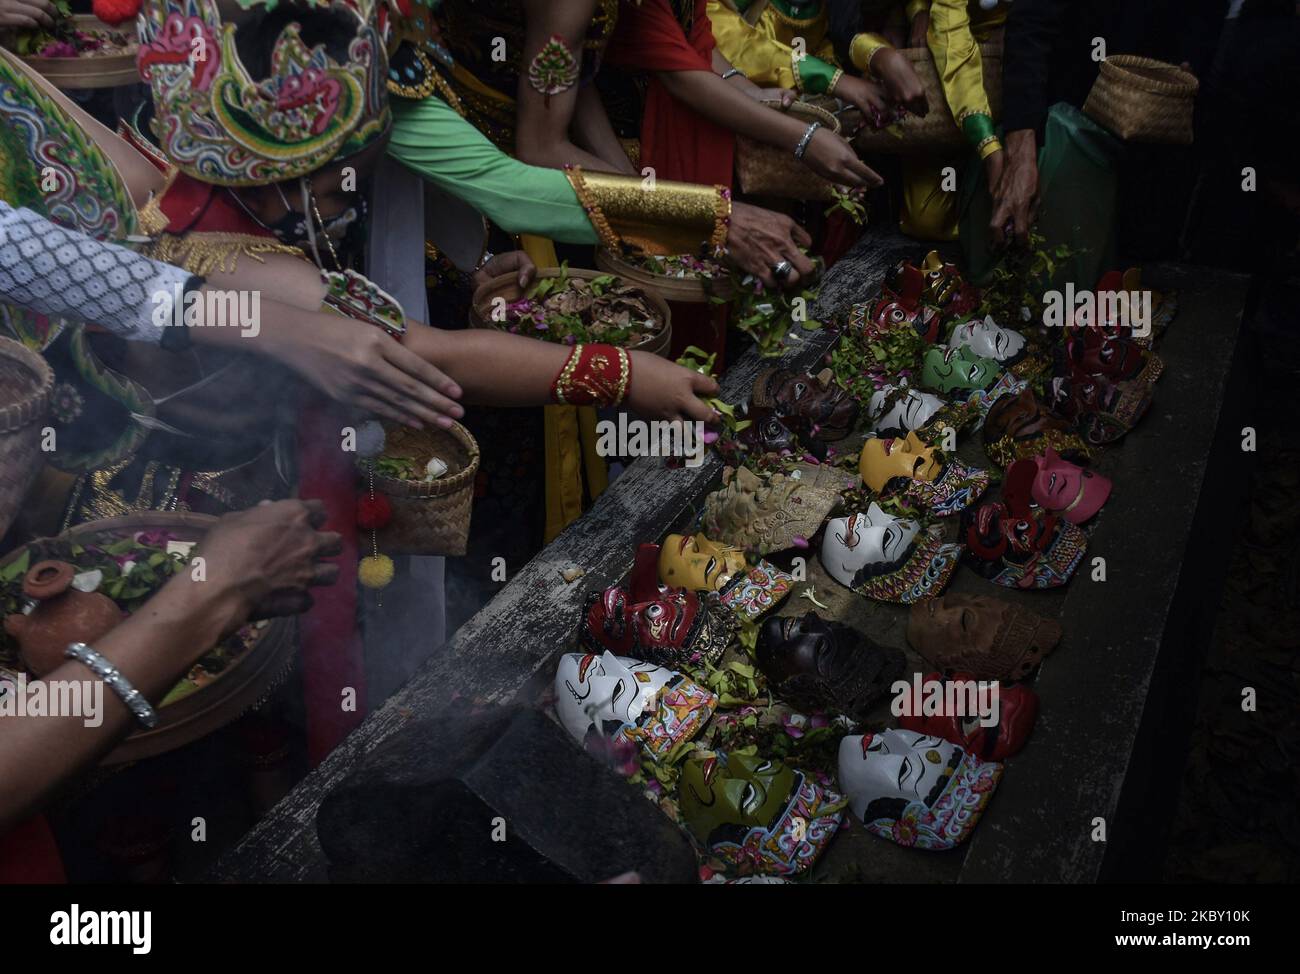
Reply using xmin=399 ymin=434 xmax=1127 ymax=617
xmin=0 ymin=338 xmax=55 ymax=536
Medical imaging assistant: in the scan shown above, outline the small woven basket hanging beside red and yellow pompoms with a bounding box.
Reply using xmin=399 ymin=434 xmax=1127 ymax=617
xmin=374 ymin=423 xmax=478 ymax=555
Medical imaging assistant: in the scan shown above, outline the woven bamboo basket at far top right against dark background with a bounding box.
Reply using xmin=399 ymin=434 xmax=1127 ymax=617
xmin=1083 ymin=55 xmax=1200 ymax=146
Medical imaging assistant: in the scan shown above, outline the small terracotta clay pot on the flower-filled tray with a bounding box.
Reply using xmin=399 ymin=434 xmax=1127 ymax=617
xmin=4 ymin=562 xmax=122 ymax=676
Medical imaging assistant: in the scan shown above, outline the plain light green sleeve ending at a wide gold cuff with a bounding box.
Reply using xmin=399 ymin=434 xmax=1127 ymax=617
xmin=389 ymin=98 xmax=597 ymax=243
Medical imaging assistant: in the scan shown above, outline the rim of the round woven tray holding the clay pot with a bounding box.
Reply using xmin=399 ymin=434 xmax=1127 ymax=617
xmin=0 ymin=511 xmax=298 ymax=765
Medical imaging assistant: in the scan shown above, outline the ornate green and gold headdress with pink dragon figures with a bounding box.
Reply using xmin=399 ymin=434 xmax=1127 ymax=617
xmin=137 ymin=0 xmax=390 ymax=186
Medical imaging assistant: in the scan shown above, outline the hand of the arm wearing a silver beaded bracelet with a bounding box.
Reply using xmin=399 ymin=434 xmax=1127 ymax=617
xmin=192 ymin=501 xmax=343 ymax=629
